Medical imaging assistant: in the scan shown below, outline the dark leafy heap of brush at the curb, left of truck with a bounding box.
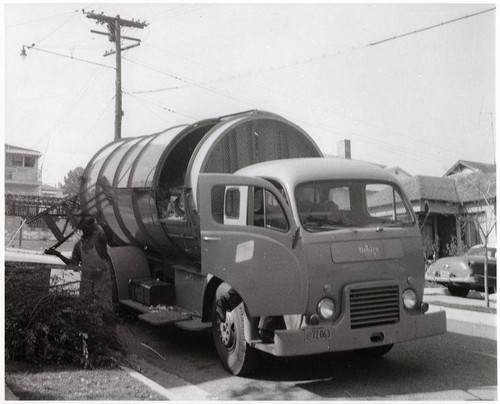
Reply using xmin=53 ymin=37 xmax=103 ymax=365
xmin=5 ymin=268 xmax=121 ymax=368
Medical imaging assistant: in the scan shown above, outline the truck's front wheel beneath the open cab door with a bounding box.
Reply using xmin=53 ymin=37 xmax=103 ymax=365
xmin=212 ymin=284 xmax=258 ymax=376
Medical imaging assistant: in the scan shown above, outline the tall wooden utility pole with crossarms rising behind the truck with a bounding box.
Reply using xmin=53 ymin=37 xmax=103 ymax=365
xmin=82 ymin=10 xmax=147 ymax=140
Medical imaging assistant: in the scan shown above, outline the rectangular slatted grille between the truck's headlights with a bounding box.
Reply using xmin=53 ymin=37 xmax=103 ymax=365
xmin=349 ymin=285 xmax=399 ymax=328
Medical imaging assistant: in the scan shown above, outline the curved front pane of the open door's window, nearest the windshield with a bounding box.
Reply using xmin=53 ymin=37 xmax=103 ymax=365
xmin=249 ymin=188 xmax=289 ymax=231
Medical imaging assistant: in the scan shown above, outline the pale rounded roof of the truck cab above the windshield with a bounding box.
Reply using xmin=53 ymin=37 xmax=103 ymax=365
xmin=235 ymin=157 xmax=399 ymax=189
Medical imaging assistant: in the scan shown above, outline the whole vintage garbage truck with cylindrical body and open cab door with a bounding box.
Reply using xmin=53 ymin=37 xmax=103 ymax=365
xmin=70 ymin=111 xmax=446 ymax=375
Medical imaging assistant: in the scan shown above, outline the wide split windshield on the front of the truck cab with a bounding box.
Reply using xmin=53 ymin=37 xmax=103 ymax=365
xmin=295 ymin=181 xmax=415 ymax=232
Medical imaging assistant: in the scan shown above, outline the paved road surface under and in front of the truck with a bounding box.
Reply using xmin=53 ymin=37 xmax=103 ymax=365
xmin=120 ymin=306 xmax=497 ymax=400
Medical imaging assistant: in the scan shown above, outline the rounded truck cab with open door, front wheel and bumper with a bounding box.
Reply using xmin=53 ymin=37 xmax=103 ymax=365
xmin=198 ymin=158 xmax=446 ymax=374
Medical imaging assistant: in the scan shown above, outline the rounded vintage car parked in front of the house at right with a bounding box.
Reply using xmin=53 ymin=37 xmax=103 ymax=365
xmin=425 ymin=245 xmax=497 ymax=297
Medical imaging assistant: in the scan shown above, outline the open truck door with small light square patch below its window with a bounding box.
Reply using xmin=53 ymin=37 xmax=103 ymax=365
xmin=198 ymin=174 xmax=308 ymax=316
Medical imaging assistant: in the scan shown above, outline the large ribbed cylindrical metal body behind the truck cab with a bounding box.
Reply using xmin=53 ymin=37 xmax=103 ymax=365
xmin=80 ymin=111 xmax=322 ymax=261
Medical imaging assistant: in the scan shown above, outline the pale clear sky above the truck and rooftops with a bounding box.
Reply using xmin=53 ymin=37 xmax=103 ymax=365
xmin=3 ymin=3 xmax=496 ymax=185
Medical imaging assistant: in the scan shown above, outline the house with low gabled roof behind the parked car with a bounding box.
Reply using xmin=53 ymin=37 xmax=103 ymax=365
xmin=400 ymin=160 xmax=496 ymax=257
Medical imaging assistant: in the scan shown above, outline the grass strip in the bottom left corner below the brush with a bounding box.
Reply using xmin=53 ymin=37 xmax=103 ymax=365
xmin=5 ymin=360 xmax=165 ymax=401
